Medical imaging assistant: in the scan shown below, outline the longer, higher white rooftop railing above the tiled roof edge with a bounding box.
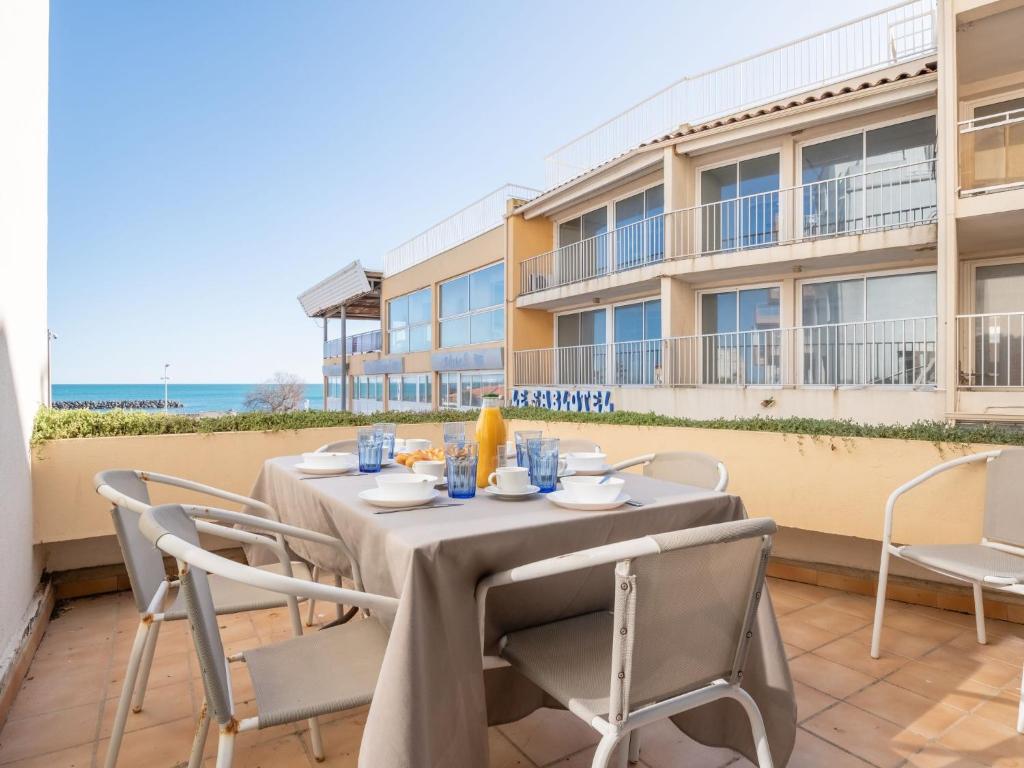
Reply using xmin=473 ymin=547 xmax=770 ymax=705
xmin=545 ymin=0 xmax=937 ymax=188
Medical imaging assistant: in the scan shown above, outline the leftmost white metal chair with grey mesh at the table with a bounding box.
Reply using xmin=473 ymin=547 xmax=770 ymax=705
xmin=94 ymin=469 xmax=361 ymax=768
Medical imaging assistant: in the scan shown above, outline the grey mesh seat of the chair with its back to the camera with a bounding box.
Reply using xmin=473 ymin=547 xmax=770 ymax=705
xmin=502 ymin=611 xmax=614 ymax=722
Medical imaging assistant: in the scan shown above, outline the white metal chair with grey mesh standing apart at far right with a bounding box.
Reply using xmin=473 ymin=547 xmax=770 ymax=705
xmin=871 ymin=449 xmax=1024 ymax=733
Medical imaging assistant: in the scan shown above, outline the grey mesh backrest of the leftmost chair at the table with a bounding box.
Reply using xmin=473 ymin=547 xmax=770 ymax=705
xmin=95 ymin=469 xmax=167 ymax=613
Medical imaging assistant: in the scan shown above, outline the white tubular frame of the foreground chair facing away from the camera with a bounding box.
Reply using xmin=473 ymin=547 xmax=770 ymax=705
xmin=476 ymin=535 xmax=773 ymax=768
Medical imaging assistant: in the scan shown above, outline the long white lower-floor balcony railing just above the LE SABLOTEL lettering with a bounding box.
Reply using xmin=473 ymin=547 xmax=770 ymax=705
xmin=515 ymin=316 xmax=936 ymax=387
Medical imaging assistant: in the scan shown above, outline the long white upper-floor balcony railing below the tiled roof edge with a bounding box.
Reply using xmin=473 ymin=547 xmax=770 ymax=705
xmin=519 ymin=159 xmax=938 ymax=294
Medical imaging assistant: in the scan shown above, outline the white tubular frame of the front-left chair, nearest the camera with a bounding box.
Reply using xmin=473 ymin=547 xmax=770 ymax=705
xmin=139 ymin=505 xmax=398 ymax=768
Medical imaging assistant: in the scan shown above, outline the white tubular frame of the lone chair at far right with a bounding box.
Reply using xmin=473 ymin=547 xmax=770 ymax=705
xmin=871 ymin=451 xmax=1024 ymax=733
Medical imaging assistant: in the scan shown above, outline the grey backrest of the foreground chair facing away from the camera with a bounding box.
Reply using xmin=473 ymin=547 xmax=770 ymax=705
xmin=609 ymin=518 xmax=775 ymax=722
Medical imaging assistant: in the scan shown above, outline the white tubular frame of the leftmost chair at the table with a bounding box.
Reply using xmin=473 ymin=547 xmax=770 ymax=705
xmin=94 ymin=470 xmax=362 ymax=768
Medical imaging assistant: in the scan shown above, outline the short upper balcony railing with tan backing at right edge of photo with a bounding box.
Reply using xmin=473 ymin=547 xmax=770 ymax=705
xmin=959 ymin=110 xmax=1024 ymax=194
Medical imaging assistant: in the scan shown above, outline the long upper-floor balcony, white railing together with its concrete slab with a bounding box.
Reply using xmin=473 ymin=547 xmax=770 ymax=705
xmin=516 ymin=157 xmax=938 ymax=308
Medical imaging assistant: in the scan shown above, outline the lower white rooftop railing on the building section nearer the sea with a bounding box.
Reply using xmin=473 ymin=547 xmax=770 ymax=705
xmin=384 ymin=184 xmax=541 ymax=278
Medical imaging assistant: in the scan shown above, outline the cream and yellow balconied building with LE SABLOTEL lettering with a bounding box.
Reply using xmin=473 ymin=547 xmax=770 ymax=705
xmin=299 ymin=0 xmax=1024 ymax=423
